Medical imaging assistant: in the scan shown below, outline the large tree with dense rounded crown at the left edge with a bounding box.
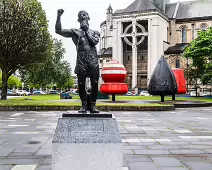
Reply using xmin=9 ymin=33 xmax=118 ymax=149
xmin=0 ymin=0 xmax=51 ymax=99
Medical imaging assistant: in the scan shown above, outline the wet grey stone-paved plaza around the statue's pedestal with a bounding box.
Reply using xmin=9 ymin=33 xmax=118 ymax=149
xmin=0 ymin=107 xmax=212 ymax=170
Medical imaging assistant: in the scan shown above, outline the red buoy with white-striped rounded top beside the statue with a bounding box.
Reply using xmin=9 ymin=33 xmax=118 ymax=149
xmin=100 ymin=60 xmax=128 ymax=101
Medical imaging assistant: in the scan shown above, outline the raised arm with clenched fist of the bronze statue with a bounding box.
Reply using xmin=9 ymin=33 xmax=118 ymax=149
xmin=55 ymin=9 xmax=73 ymax=37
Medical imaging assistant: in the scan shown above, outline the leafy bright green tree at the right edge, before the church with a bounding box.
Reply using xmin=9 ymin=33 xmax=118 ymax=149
xmin=184 ymin=27 xmax=212 ymax=84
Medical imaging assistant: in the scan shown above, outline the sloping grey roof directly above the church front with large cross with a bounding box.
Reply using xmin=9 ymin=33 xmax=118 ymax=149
xmin=115 ymin=0 xmax=160 ymax=14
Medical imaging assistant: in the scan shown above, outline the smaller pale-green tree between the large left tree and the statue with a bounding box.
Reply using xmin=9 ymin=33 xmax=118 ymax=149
xmin=20 ymin=39 xmax=73 ymax=88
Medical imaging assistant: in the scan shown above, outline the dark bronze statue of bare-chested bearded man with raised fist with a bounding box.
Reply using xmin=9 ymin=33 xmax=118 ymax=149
xmin=55 ymin=9 xmax=100 ymax=113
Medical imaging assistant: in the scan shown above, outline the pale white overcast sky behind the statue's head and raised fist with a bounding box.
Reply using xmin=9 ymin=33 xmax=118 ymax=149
xmin=38 ymin=0 xmax=189 ymax=73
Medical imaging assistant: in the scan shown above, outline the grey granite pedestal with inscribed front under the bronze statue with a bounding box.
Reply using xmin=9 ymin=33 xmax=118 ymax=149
xmin=52 ymin=114 xmax=122 ymax=170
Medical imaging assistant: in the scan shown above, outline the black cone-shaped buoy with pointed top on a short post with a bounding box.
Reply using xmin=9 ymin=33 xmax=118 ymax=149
xmin=147 ymin=56 xmax=178 ymax=102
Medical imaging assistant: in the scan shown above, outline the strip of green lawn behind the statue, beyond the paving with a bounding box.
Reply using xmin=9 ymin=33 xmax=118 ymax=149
xmin=0 ymin=95 xmax=209 ymax=106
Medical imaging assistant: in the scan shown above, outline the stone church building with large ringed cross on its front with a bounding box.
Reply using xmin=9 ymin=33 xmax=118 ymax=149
xmin=99 ymin=0 xmax=212 ymax=89
